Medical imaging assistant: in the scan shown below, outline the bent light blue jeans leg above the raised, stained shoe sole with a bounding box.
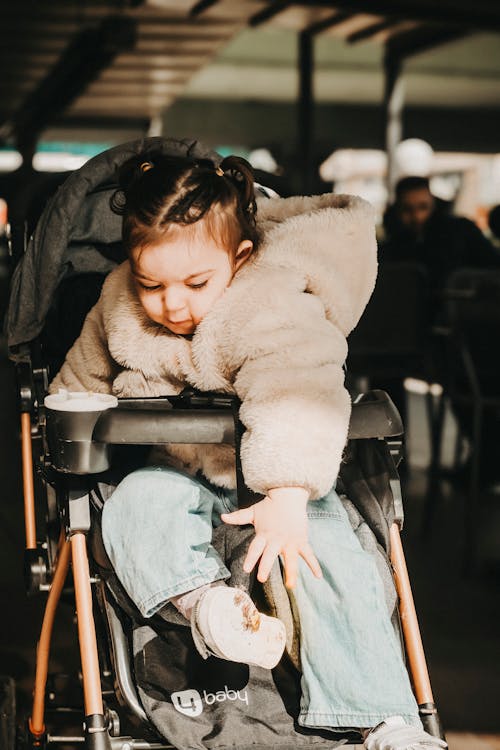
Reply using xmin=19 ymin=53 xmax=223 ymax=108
xmin=102 ymin=466 xmax=229 ymax=617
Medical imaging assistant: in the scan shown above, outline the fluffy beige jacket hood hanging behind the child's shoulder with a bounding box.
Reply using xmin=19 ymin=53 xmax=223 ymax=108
xmin=252 ymin=193 xmax=377 ymax=336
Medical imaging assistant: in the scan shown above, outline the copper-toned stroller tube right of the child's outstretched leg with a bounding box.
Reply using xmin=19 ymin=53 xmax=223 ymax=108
xmin=390 ymin=523 xmax=434 ymax=705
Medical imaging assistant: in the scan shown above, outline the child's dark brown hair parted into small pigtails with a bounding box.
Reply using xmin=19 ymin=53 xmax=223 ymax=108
xmin=110 ymin=152 xmax=258 ymax=258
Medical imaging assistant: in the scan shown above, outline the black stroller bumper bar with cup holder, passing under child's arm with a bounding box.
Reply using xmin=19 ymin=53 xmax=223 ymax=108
xmin=46 ymin=391 xmax=403 ymax=474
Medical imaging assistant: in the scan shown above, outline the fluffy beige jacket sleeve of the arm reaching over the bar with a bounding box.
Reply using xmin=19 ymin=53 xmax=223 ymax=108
xmin=234 ymin=290 xmax=351 ymax=499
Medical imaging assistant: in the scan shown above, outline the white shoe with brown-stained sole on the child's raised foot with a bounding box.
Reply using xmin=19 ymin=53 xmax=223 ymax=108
xmin=191 ymin=586 xmax=286 ymax=669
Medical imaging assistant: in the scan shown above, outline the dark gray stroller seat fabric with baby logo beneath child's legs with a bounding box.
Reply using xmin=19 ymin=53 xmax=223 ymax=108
xmin=94 ymin=485 xmax=399 ymax=750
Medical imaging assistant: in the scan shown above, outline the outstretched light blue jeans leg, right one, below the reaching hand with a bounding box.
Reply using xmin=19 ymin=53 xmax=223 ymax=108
xmin=293 ymin=490 xmax=420 ymax=728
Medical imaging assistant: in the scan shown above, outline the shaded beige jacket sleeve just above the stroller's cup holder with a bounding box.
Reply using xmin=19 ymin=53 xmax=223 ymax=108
xmin=49 ymin=297 xmax=118 ymax=393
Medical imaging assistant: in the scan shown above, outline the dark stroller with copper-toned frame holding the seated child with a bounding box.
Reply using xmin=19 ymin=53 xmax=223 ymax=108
xmin=6 ymin=138 xmax=443 ymax=750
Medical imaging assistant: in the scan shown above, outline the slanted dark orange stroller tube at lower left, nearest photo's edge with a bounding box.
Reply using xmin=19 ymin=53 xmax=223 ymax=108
xmin=29 ymin=537 xmax=71 ymax=737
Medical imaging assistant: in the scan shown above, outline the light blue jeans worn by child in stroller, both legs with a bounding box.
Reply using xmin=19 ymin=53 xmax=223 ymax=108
xmin=102 ymin=467 xmax=420 ymax=727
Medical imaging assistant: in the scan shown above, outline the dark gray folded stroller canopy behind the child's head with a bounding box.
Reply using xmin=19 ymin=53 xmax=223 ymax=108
xmin=5 ymin=137 xmax=221 ymax=359
